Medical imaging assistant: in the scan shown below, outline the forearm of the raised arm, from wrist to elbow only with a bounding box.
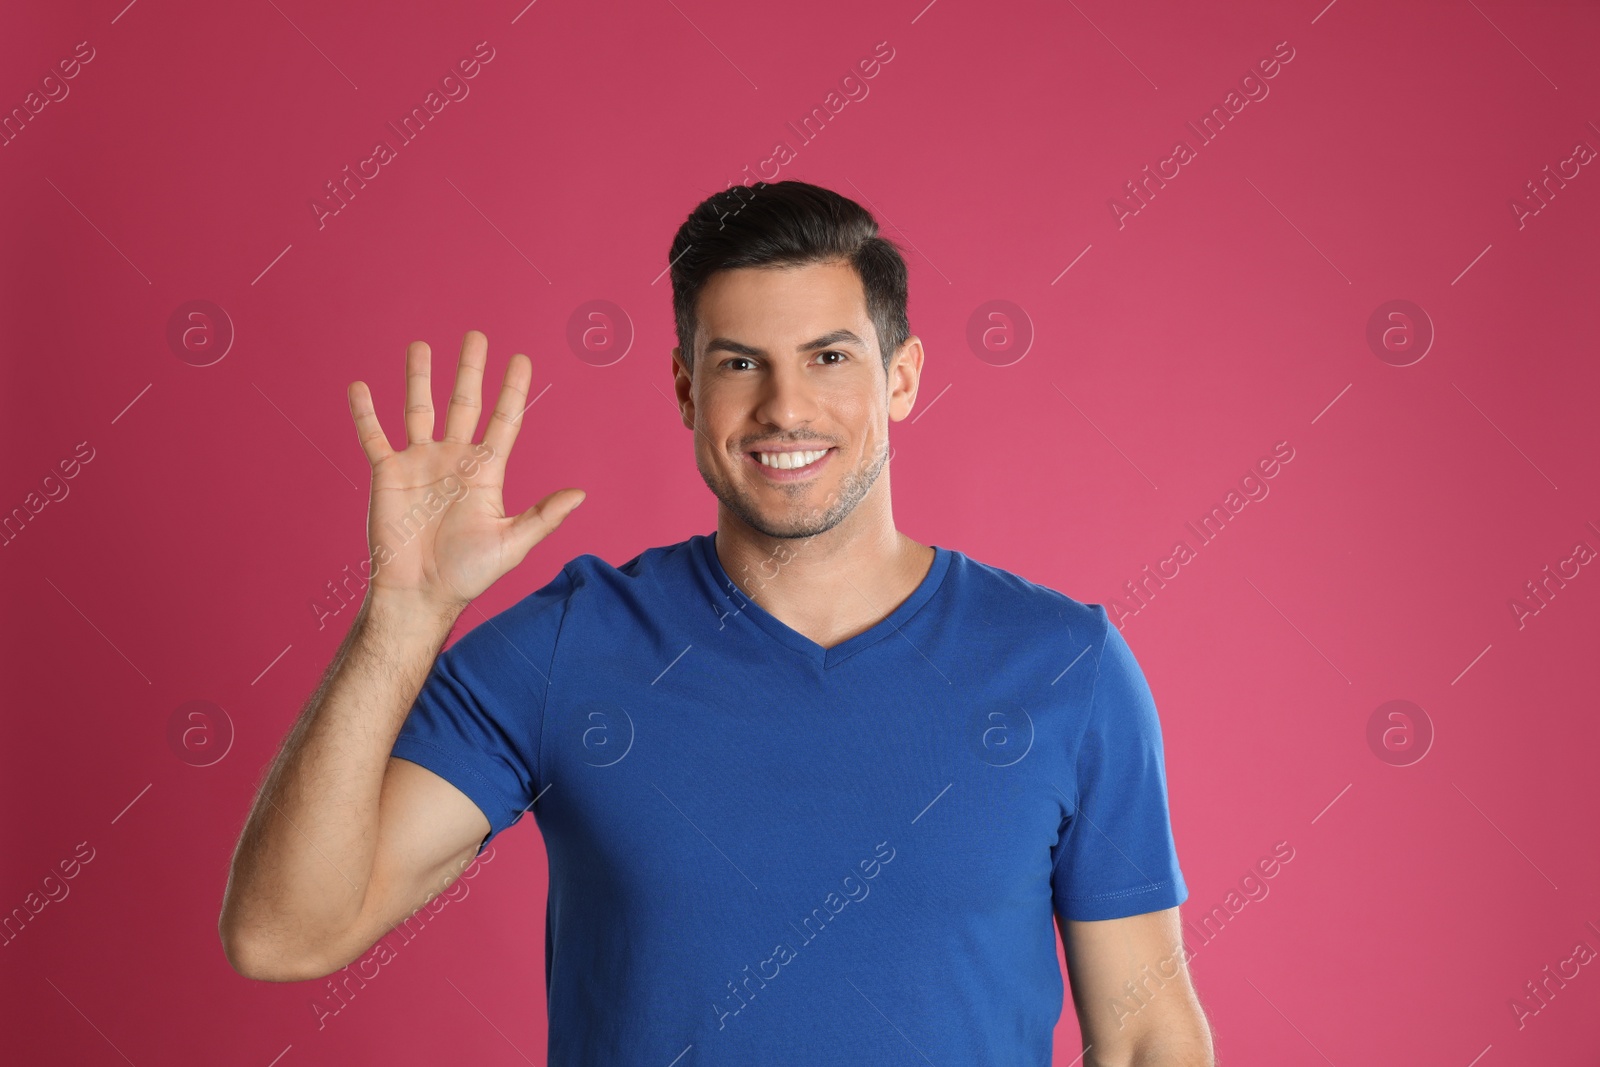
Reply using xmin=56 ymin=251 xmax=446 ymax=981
xmin=221 ymin=597 xmax=456 ymax=969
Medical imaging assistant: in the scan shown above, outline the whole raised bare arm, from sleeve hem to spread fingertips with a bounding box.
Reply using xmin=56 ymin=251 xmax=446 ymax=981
xmin=218 ymin=331 xmax=582 ymax=981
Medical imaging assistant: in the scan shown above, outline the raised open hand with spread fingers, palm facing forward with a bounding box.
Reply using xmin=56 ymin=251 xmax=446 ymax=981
xmin=349 ymin=330 xmax=586 ymax=613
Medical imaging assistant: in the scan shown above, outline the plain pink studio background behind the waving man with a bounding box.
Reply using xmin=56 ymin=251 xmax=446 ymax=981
xmin=0 ymin=0 xmax=1600 ymax=1067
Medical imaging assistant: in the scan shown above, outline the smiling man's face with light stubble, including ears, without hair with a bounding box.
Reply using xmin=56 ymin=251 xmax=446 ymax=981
xmin=672 ymin=262 xmax=922 ymax=537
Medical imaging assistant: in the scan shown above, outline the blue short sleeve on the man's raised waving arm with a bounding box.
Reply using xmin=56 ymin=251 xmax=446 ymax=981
xmin=390 ymin=565 xmax=573 ymax=853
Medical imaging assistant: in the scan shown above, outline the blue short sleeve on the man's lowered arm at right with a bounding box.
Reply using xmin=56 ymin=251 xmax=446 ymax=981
xmin=1051 ymin=605 xmax=1189 ymax=920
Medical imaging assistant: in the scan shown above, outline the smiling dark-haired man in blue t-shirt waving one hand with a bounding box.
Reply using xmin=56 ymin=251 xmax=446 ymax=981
xmin=221 ymin=181 xmax=1213 ymax=1067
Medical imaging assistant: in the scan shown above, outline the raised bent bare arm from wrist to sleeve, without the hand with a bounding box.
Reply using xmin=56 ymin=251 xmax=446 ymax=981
xmin=219 ymin=598 xmax=488 ymax=981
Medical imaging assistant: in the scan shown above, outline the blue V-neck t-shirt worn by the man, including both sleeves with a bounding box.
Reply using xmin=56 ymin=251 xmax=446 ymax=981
xmin=394 ymin=534 xmax=1189 ymax=1067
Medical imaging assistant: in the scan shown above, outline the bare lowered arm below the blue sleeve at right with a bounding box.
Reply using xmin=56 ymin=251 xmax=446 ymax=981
xmin=1056 ymin=907 xmax=1216 ymax=1067
